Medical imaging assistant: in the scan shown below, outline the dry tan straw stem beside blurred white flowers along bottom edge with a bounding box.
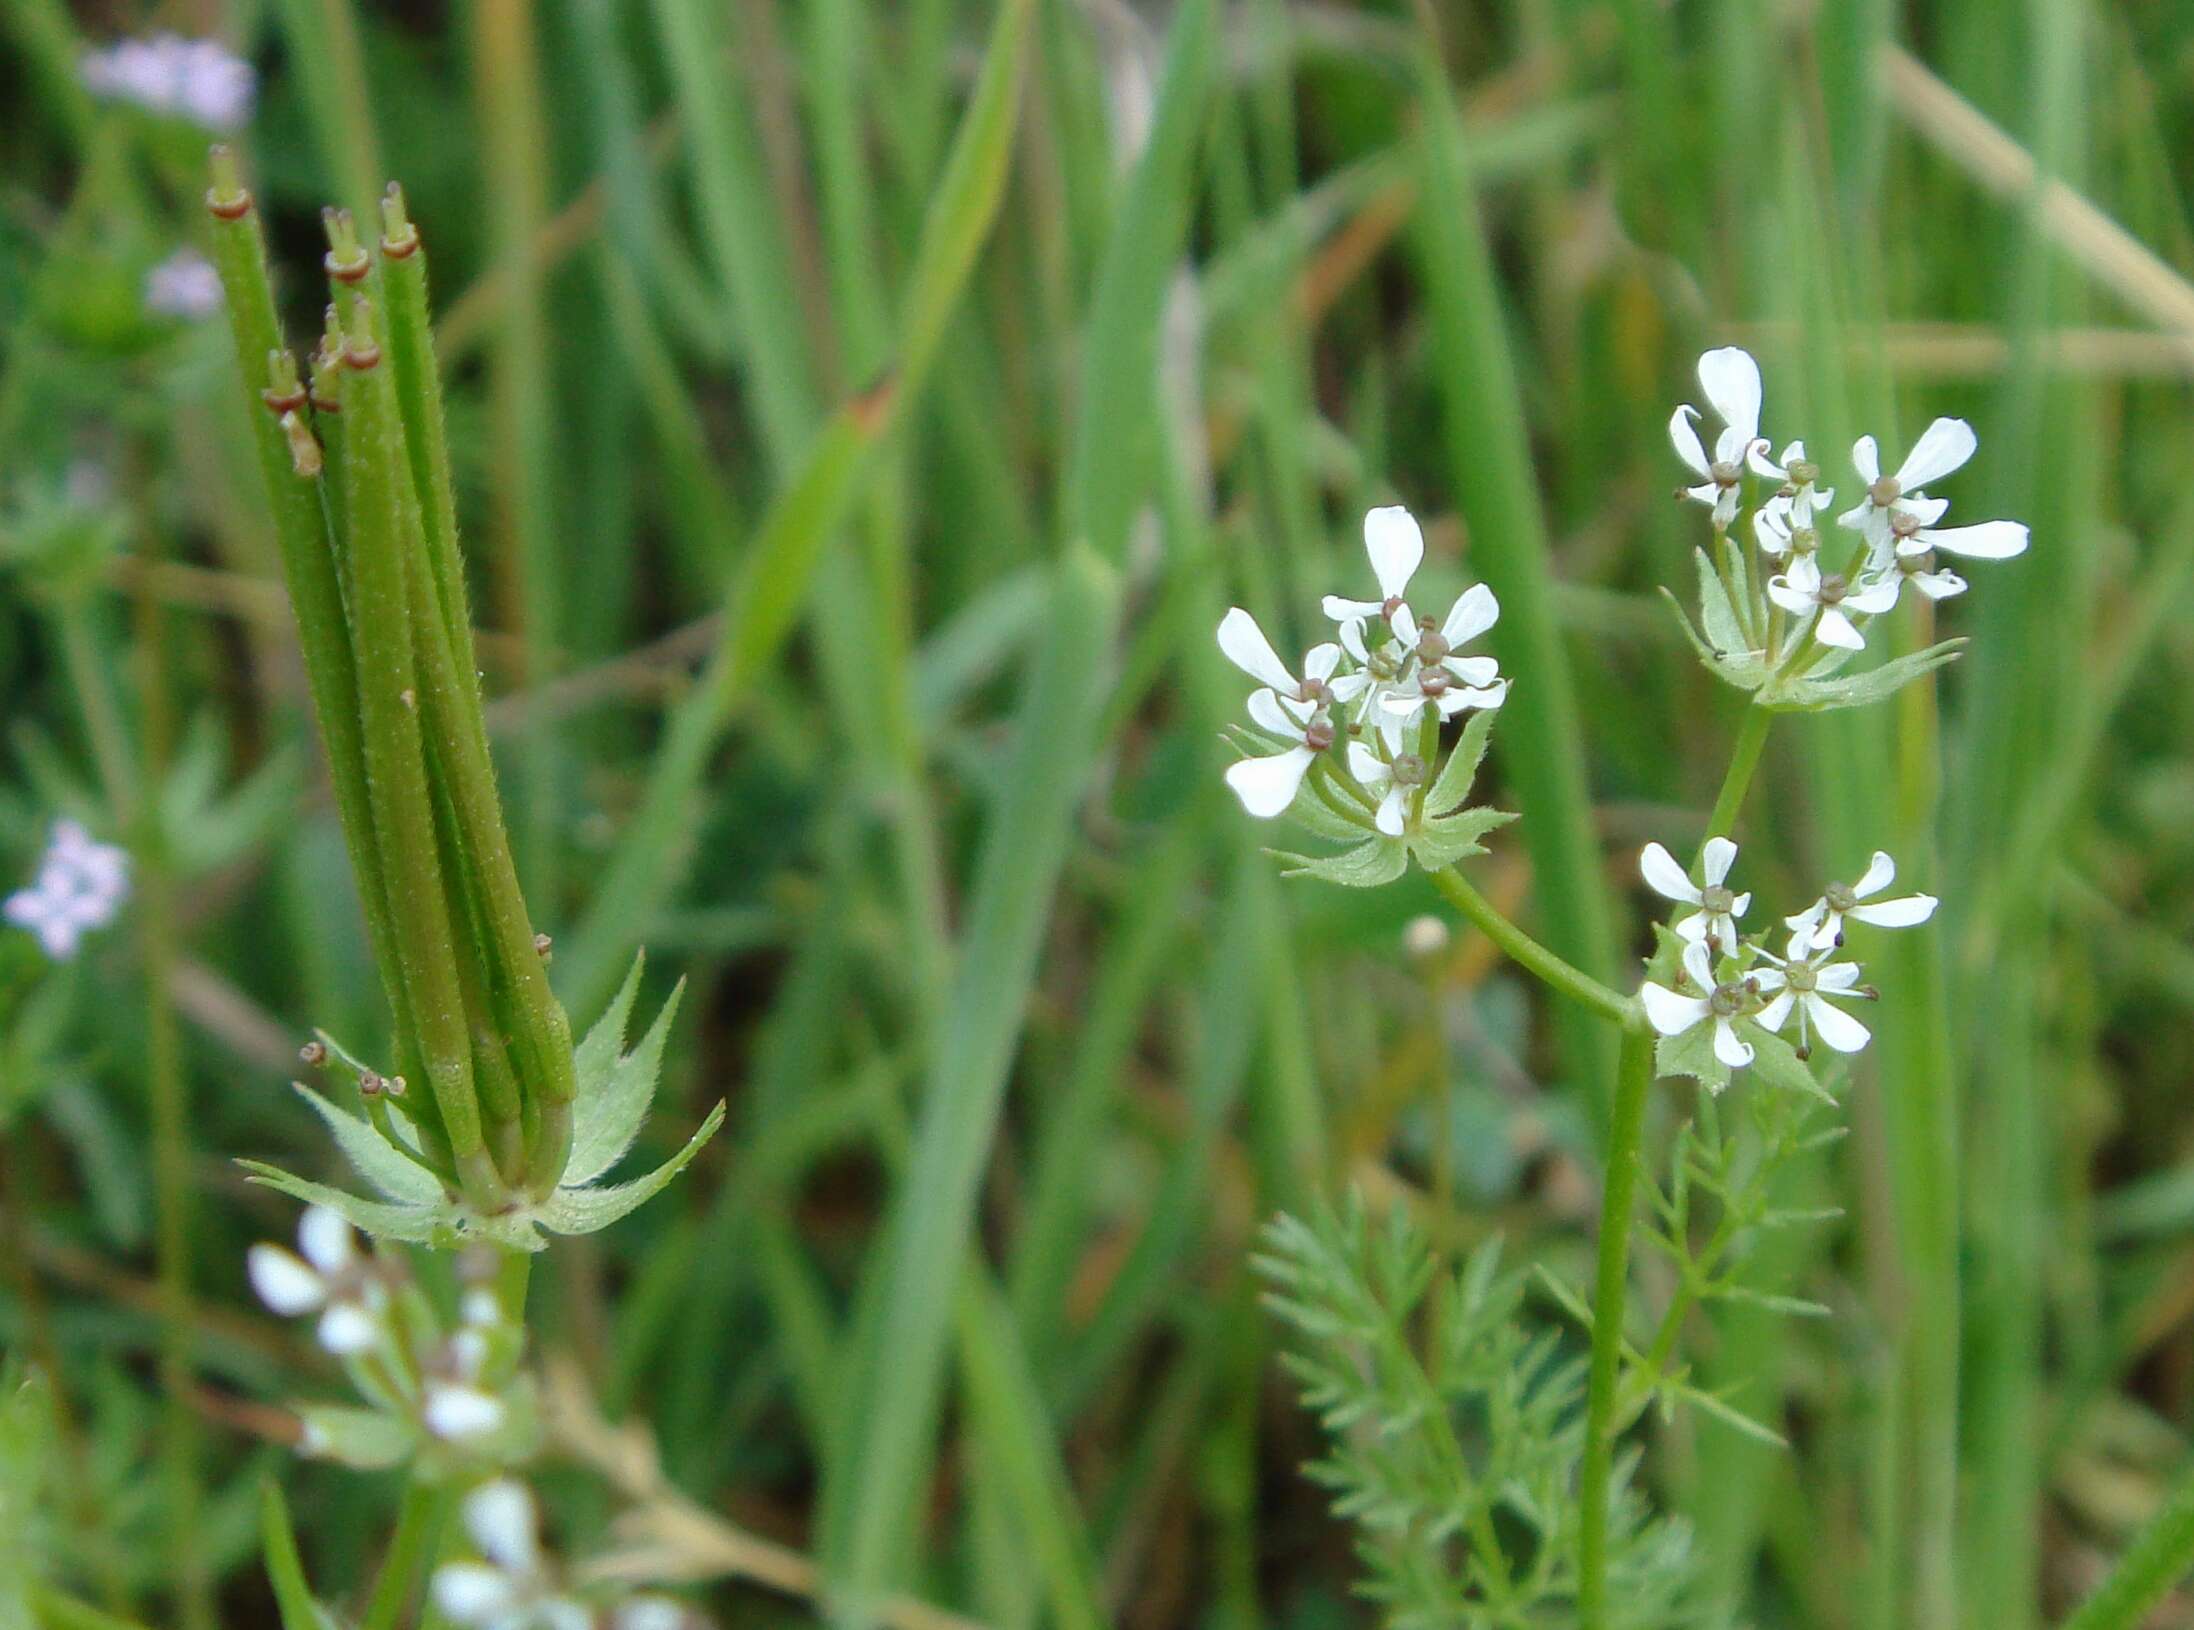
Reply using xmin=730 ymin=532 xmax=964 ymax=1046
xmin=542 ymin=1358 xmax=985 ymax=1630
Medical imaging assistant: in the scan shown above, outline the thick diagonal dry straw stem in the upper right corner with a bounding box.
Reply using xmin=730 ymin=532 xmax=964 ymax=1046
xmin=1876 ymin=46 xmax=2194 ymax=333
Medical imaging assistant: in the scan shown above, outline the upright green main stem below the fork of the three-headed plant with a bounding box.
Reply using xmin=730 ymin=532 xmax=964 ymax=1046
xmin=1577 ymin=1029 xmax=1652 ymax=1630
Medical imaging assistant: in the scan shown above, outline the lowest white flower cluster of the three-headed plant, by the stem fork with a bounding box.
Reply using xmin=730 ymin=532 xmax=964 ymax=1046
xmin=1639 ymin=838 xmax=1935 ymax=1071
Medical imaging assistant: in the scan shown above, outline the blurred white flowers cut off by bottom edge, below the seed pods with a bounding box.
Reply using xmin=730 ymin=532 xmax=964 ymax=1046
xmin=432 ymin=1476 xmax=704 ymax=1630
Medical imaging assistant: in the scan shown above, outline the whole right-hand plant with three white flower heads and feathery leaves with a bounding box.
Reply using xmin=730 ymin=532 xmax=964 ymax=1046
xmin=1218 ymin=347 xmax=2027 ymax=1630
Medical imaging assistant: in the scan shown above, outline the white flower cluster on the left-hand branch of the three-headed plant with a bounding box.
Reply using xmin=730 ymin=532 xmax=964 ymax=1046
xmin=1218 ymin=505 xmax=1507 ymax=838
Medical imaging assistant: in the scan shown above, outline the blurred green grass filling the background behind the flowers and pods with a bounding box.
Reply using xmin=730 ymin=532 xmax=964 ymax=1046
xmin=0 ymin=0 xmax=2194 ymax=1630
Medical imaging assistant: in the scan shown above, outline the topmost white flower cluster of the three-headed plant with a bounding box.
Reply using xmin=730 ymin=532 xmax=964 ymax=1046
xmin=1667 ymin=344 xmax=2027 ymax=663
